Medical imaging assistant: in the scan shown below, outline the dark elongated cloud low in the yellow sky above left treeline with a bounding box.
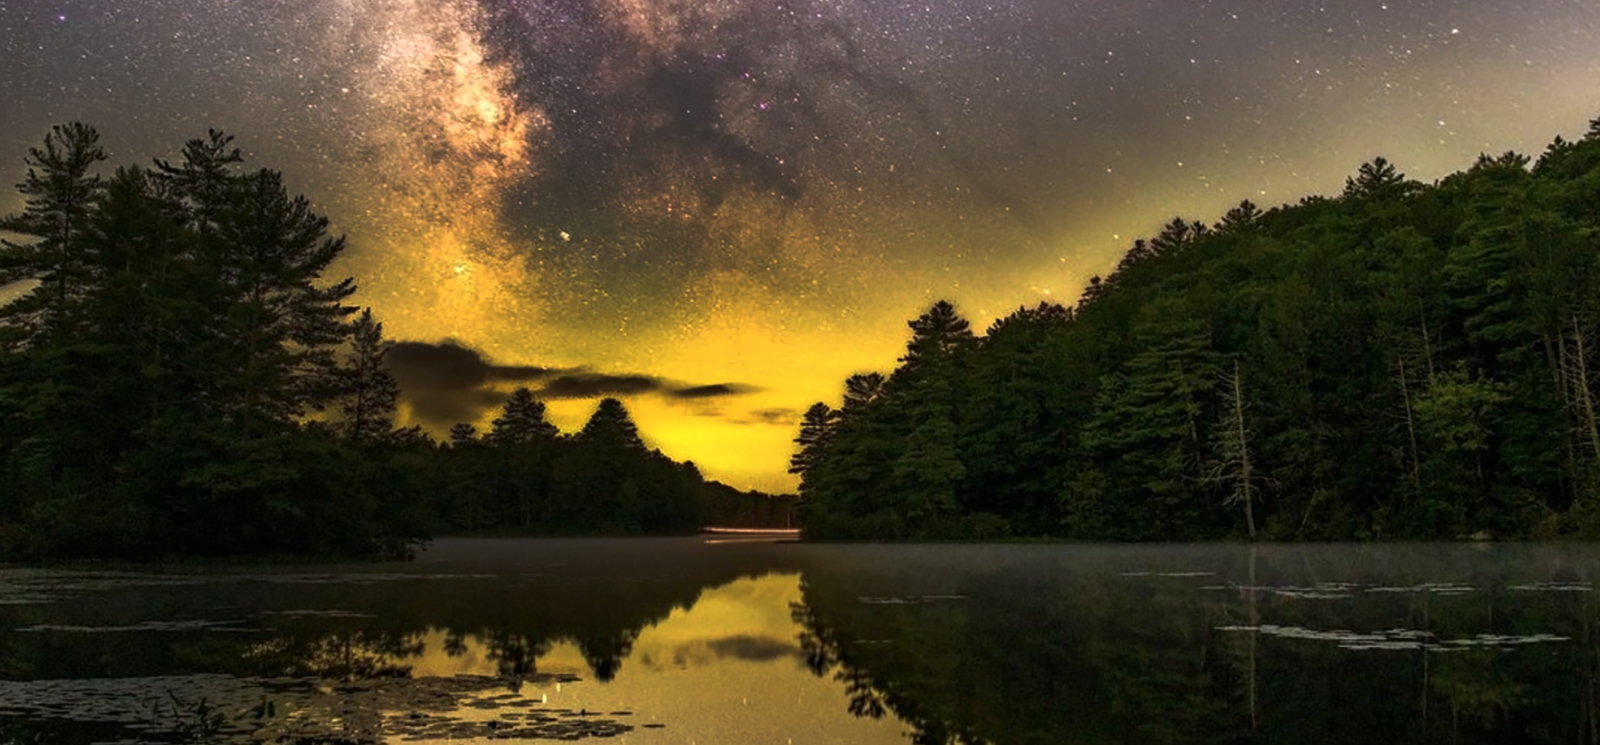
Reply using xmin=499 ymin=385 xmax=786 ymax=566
xmin=386 ymin=341 xmax=760 ymax=427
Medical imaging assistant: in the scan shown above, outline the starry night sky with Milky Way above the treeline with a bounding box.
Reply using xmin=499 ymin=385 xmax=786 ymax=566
xmin=0 ymin=0 xmax=1600 ymax=491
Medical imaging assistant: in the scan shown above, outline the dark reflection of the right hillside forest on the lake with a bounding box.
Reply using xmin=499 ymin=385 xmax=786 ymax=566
xmin=792 ymin=547 xmax=1600 ymax=745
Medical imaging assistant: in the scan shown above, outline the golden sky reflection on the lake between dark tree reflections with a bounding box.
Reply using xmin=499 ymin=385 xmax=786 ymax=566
xmin=406 ymin=574 xmax=906 ymax=745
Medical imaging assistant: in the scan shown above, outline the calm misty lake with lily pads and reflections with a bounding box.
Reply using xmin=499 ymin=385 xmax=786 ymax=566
xmin=0 ymin=539 xmax=1600 ymax=743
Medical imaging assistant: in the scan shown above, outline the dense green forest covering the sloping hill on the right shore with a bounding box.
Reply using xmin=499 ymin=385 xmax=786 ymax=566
xmin=790 ymin=120 xmax=1600 ymax=540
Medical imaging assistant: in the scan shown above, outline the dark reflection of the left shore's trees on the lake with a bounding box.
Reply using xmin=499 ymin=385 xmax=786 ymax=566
xmin=0 ymin=539 xmax=795 ymax=681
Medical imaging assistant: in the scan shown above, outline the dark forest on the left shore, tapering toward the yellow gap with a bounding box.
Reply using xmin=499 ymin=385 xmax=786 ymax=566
xmin=0 ymin=123 xmax=792 ymax=560
